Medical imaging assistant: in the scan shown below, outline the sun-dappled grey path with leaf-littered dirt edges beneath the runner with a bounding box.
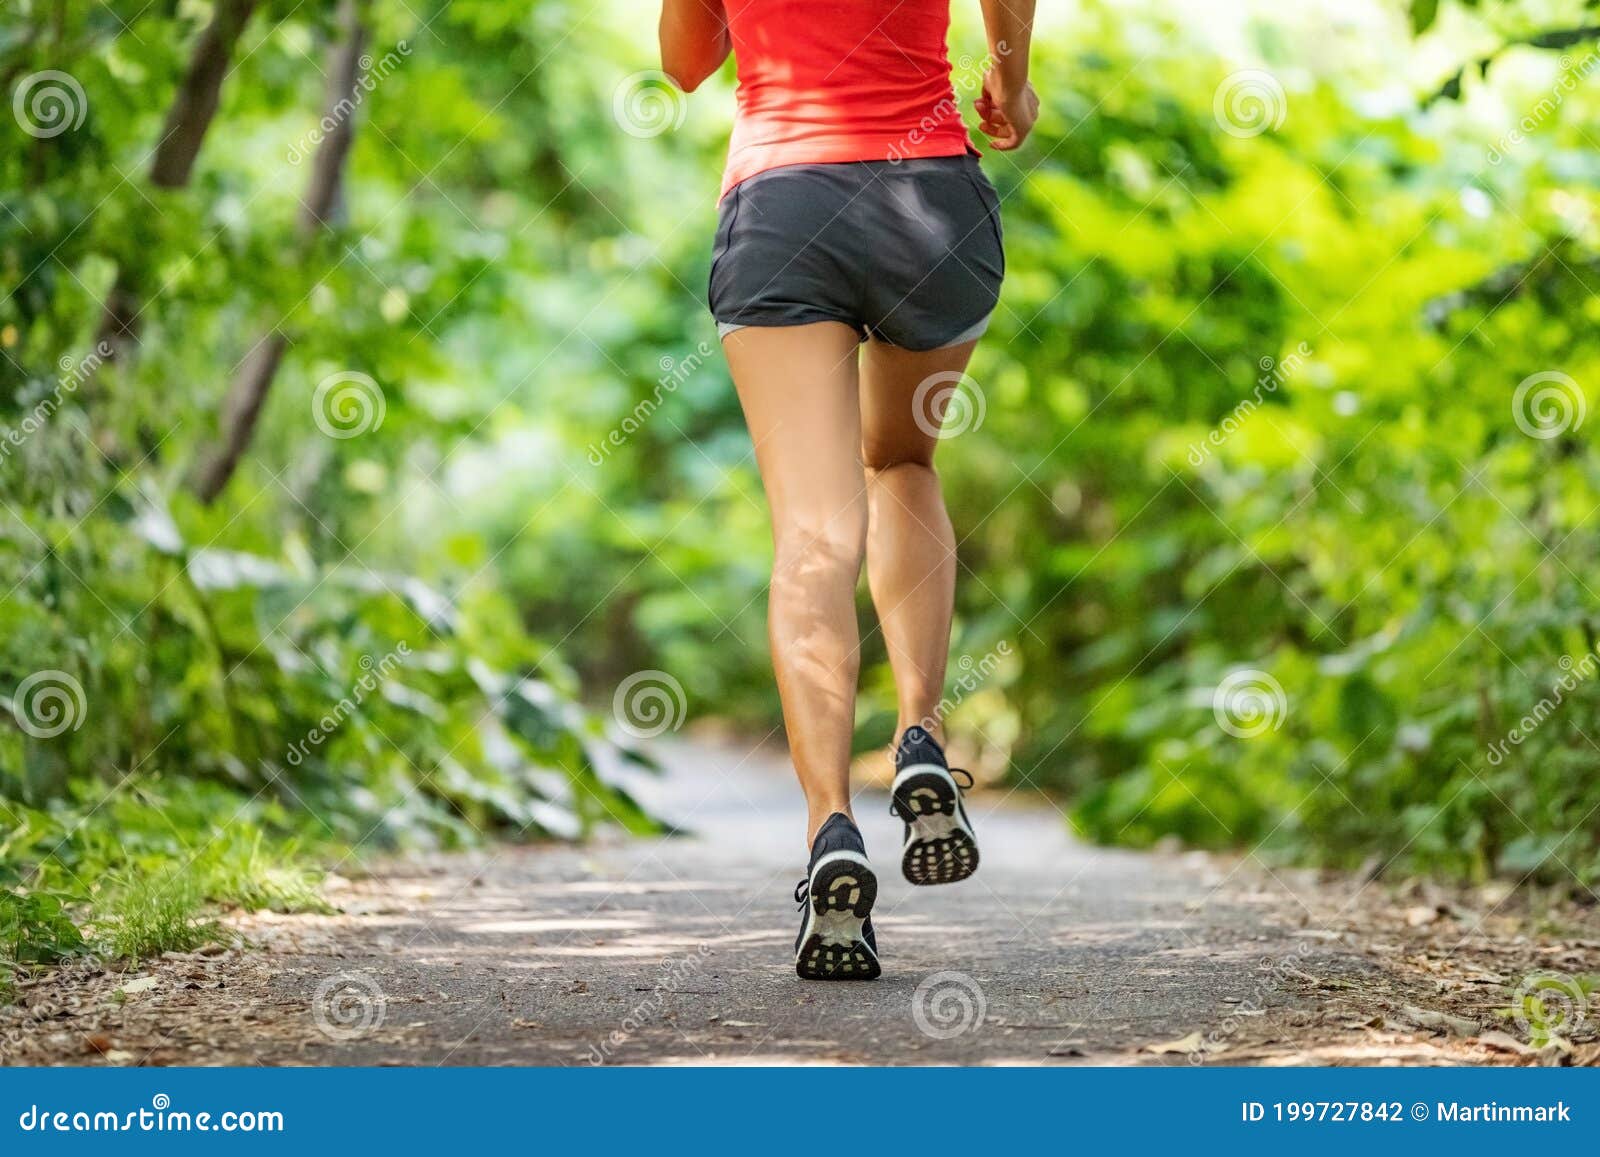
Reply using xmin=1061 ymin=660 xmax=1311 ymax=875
xmin=9 ymin=743 xmax=1600 ymax=1064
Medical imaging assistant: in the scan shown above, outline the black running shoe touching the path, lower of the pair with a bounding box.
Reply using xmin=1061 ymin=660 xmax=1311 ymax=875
xmin=795 ymin=811 xmax=883 ymax=981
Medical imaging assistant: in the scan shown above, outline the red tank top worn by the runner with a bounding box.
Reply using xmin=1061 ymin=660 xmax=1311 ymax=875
xmin=722 ymin=0 xmax=978 ymax=194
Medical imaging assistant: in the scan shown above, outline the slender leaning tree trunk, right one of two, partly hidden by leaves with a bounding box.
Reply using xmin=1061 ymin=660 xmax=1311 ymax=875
xmin=194 ymin=0 xmax=366 ymax=506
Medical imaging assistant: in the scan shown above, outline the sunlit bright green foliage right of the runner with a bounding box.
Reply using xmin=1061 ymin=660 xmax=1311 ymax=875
xmin=972 ymin=0 xmax=1600 ymax=882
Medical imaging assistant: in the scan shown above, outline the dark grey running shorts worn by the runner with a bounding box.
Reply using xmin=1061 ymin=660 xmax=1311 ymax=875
xmin=710 ymin=155 xmax=1005 ymax=349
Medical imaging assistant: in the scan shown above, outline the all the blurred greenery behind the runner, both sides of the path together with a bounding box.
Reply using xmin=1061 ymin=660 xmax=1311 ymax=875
xmin=0 ymin=0 xmax=1600 ymax=984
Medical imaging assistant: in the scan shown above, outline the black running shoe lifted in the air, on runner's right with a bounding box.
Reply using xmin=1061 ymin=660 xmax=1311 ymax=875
xmin=890 ymin=727 xmax=978 ymax=883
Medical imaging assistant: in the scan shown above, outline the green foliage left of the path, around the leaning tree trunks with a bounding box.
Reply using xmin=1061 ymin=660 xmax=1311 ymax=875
xmin=0 ymin=0 xmax=654 ymax=979
